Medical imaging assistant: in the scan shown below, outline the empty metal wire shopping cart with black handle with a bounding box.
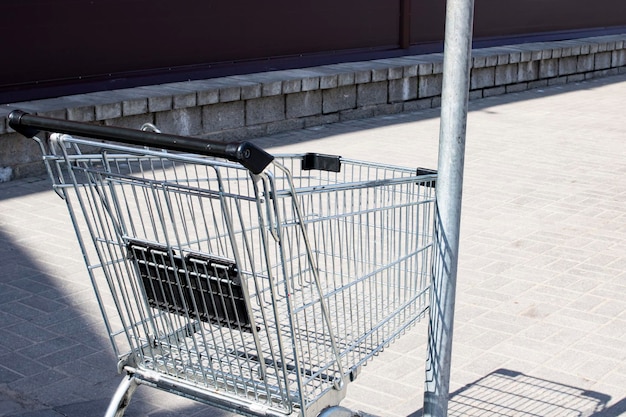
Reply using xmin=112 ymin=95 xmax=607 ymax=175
xmin=9 ymin=111 xmax=436 ymax=417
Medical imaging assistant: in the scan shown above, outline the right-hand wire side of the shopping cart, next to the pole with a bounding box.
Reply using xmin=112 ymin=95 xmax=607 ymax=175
xmin=276 ymin=156 xmax=435 ymax=372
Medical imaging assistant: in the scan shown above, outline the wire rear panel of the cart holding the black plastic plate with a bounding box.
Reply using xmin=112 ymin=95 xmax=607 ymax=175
xmin=50 ymin=148 xmax=326 ymax=414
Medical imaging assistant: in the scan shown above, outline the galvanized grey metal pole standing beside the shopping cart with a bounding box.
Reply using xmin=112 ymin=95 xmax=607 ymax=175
xmin=424 ymin=0 xmax=474 ymax=417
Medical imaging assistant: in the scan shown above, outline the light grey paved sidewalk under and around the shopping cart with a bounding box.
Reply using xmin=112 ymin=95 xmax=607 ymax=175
xmin=0 ymin=75 xmax=626 ymax=417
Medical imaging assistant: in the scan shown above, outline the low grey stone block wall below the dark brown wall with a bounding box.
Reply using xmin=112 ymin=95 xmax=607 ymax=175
xmin=0 ymin=34 xmax=626 ymax=179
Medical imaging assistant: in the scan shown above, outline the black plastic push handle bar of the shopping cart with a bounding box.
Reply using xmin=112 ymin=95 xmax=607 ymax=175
xmin=8 ymin=110 xmax=274 ymax=174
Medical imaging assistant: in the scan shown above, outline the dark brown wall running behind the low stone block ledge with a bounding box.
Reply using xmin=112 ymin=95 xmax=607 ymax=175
xmin=0 ymin=0 xmax=626 ymax=102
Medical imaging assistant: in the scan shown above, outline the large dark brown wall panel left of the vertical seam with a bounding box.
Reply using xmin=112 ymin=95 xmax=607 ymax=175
xmin=0 ymin=0 xmax=399 ymax=84
